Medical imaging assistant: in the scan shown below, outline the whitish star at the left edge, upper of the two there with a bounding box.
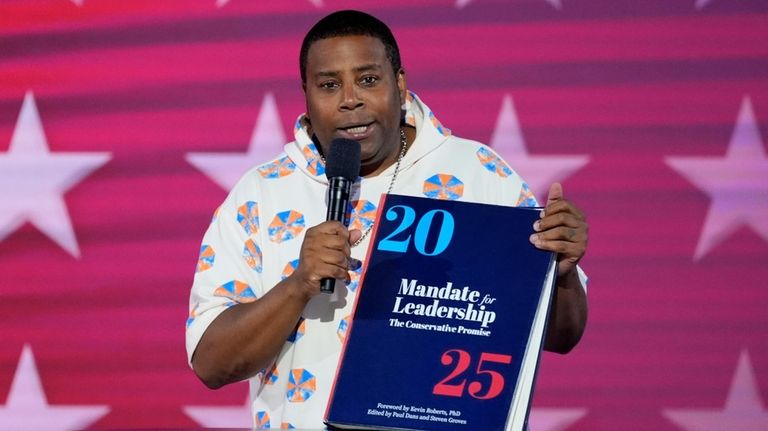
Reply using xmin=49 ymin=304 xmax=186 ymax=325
xmin=0 ymin=91 xmax=111 ymax=258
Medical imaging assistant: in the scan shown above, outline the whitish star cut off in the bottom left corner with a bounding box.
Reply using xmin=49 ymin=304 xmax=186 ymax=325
xmin=0 ymin=345 xmax=109 ymax=431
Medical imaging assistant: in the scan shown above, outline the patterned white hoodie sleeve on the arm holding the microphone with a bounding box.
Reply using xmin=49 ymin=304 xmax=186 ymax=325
xmin=186 ymin=195 xmax=264 ymax=365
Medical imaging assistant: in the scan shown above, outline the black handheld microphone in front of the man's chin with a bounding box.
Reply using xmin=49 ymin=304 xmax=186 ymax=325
xmin=320 ymin=138 xmax=360 ymax=293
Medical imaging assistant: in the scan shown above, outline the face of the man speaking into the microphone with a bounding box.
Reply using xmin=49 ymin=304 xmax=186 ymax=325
xmin=304 ymin=36 xmax=405 ymax=176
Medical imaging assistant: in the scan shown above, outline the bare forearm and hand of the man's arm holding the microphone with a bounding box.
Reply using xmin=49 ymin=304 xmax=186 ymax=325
xmin=192 ymin=221 xmax=361 ymax=388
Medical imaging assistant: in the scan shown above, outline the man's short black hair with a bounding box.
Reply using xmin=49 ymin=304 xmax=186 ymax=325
xmin=299 ymin=10 xmax=402 ymax=83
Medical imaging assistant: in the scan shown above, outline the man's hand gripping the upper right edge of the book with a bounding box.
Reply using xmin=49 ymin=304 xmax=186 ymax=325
xmin=530 ymin=183 xmax=589 ymax=277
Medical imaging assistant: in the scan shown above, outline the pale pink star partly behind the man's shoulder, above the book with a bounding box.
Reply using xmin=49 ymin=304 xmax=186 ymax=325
xmin=491 ymin=95 xmax=589 ymax=203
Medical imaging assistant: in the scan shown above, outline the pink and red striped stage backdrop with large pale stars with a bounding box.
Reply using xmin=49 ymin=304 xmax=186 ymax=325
xmin=0 ymin=0 xmax=768 ymax=431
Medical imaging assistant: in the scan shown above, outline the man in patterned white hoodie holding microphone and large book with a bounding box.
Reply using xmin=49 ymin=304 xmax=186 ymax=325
xmin=187 ymin=11 xmax=587 ymax=428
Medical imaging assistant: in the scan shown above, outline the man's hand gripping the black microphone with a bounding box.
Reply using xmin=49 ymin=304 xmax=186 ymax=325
xmin=291 ymin=221 xmax=362 ymax=297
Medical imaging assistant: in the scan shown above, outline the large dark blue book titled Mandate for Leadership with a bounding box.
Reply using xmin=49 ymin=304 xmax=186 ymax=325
xmin=325 ymin=195 xmax=557 ymax=431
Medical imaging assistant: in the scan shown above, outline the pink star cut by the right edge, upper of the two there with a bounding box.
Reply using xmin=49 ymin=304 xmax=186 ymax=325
xmin=666 ymin=96 xmax=768 ymax=260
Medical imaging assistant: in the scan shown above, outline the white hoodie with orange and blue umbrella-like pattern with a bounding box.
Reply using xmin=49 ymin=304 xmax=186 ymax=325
xmin=186 ymin=93 xmax=536 ymax=428
